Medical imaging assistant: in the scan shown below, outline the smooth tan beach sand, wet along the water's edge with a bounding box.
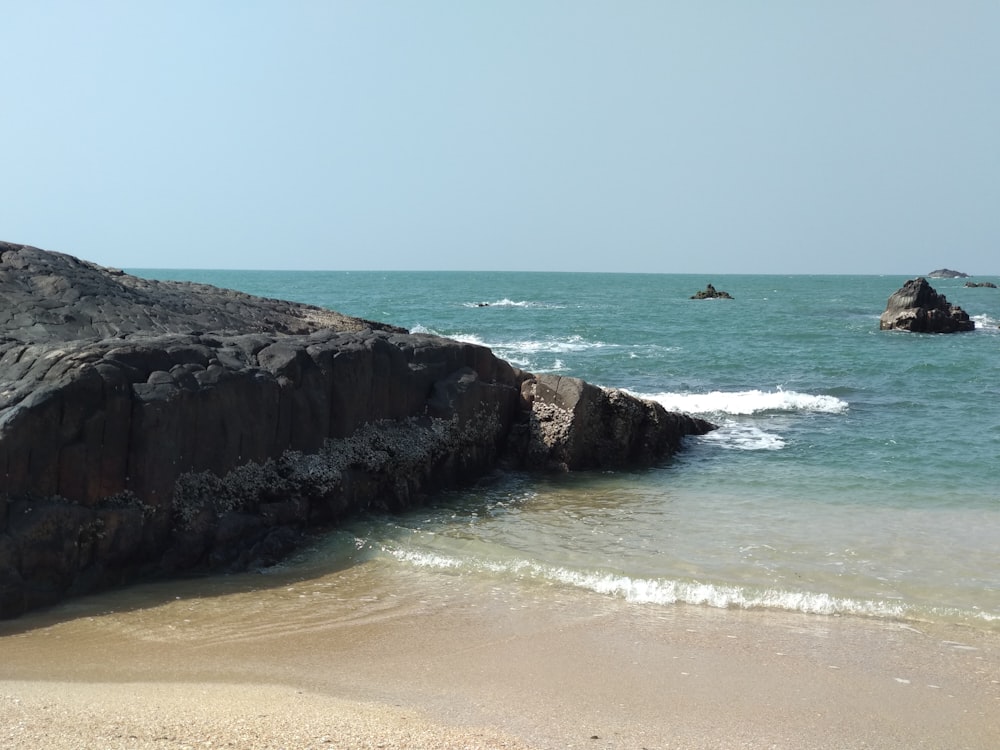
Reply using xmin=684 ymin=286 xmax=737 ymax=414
xmin=0 ymin=566 xmax=1000 ymax=750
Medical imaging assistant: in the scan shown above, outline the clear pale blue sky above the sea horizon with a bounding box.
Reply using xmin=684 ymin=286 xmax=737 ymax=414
xmin=0 ymin=0 xmax=1000 ymax=275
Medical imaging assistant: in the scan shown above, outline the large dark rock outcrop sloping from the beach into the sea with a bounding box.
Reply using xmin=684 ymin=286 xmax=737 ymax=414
xmin=0 ymin=243 xmax=712 ymax=617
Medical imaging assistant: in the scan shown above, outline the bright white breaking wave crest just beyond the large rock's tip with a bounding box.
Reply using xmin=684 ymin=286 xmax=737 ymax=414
xmin=638 ymin=389 xmax=847 ymax=416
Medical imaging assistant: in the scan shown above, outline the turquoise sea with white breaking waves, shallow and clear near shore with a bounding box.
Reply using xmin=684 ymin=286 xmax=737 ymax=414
xmin=134 ymin=270 xmax=1000 ymax=630
